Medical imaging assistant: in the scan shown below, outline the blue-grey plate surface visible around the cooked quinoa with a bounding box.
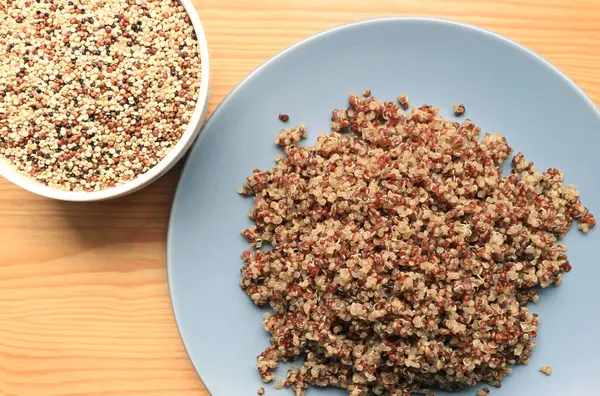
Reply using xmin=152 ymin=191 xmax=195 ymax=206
xmin=168 ymin=18 xmax=600 ymax=396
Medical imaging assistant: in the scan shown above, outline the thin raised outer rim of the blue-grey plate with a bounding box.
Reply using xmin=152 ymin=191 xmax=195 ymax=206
xmin=166 ymin=16 xmax=600 ymax=394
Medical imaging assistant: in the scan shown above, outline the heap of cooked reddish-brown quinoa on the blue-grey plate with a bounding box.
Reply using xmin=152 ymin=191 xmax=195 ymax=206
xmin=240 ymin=95 xmax=595 ymax=396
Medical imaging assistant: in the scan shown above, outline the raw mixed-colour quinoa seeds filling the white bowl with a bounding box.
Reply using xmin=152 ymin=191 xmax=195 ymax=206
xmin=0 ymin=0 xmax=201 ymax=191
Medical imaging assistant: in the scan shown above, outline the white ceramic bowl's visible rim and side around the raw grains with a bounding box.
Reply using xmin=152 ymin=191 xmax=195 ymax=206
xmin=0 ymin=0 xmax=210 ymax=202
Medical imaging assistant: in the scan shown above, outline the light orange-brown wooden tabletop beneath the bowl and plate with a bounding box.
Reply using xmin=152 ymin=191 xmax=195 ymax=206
xmin=0 ymin=0 xmax=600 ymax=396
